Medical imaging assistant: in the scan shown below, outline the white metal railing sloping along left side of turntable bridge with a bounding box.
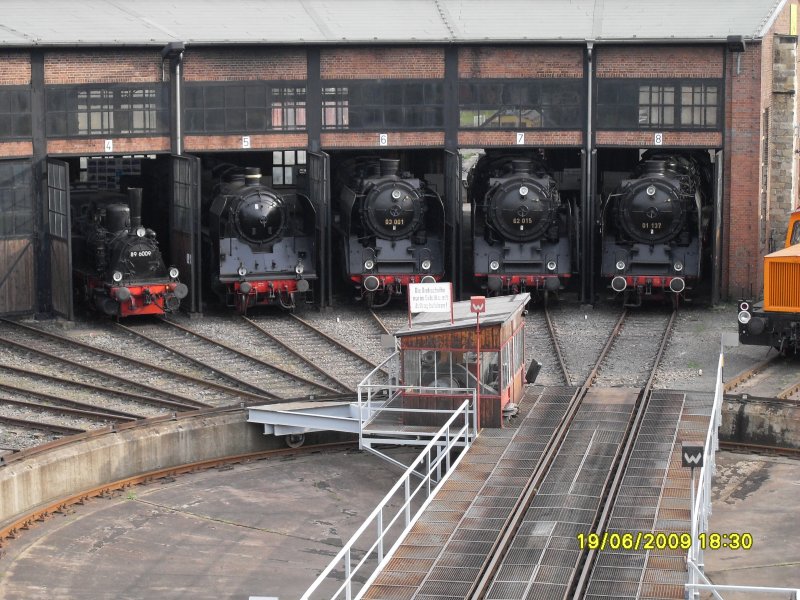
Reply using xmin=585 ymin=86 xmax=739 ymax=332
xmin=301 ymin=396 xmax=475 ymax=600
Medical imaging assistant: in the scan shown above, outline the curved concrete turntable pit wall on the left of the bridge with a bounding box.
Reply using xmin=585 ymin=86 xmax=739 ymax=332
xmin=0 ymin=408 xmax=352 ymax=529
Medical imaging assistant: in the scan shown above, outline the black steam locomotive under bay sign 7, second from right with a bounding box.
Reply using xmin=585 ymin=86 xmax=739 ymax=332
xmin=468 ymin=153 xmax=573 ymax=296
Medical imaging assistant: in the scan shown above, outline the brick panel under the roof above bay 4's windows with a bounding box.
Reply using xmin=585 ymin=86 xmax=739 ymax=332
xmin=44 ymin=48 xmax=162 ymax=84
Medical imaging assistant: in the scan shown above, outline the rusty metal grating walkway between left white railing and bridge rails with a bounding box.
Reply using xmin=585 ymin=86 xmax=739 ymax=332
xmin=364 ymin=388 xmax=575 ymax=600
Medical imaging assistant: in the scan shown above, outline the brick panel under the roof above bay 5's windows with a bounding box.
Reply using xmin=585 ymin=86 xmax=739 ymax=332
xmin=183 ymin=48 xmax=307 ymax=81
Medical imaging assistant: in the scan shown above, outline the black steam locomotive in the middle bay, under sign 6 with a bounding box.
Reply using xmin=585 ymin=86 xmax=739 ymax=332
xmin=335 ymin=157 xmax=445 ymax=307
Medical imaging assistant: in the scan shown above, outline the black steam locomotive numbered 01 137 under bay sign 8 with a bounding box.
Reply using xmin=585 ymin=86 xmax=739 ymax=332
xmin=601 ymin=150 xmax=712 ymax=306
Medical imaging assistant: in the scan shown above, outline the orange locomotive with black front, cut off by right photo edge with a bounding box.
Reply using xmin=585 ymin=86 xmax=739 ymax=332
xmin=737 ymin=210 xmax=800 ymax=356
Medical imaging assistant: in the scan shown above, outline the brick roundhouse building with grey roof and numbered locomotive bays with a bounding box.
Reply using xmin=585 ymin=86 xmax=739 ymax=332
xmin=0 ymin=0 xmax=798 ymax=316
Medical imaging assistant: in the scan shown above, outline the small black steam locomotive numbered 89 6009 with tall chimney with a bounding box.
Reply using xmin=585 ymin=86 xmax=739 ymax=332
xmin=70 ymin=188 xmax=189 ymax=317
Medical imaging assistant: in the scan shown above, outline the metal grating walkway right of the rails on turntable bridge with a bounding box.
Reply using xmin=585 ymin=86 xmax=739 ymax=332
xmin=585 ymin=392 xmax=689 ymax=600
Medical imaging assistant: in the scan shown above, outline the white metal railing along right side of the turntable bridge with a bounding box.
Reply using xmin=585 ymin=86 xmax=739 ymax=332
xmin=686 ymin=351 xmax=800 ymax=600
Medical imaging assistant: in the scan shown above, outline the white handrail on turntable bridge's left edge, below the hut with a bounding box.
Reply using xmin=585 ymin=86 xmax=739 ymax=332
xmin=301 ymin=398 xmax=474 ymax=600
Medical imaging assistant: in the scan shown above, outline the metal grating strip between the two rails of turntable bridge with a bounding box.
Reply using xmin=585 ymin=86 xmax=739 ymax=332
xmin=478 ymin=388 xmax=639 ymax=600
